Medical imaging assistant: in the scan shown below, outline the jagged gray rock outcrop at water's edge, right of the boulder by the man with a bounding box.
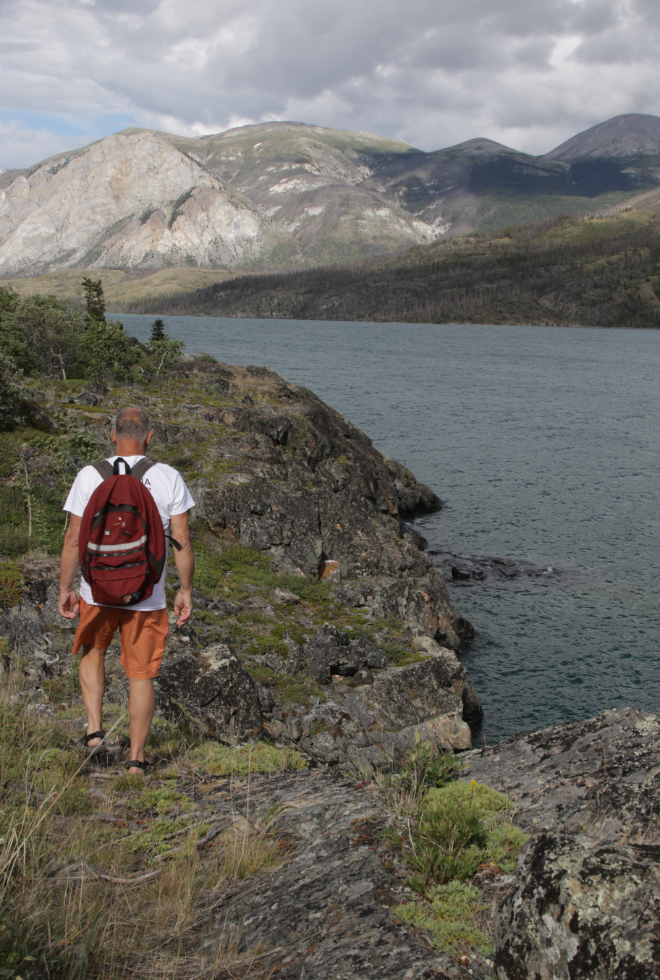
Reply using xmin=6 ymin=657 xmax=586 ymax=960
xmin=263 ymin=624 xmax=481 ymax=772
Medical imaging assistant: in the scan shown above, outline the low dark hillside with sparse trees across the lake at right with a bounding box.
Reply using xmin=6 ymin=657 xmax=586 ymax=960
xmin=124 ymin=193 xmax=660 ymax=327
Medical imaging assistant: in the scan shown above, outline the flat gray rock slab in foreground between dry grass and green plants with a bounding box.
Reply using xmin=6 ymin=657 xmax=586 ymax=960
xmin=193 ymin=770 xmax=448 ymax=980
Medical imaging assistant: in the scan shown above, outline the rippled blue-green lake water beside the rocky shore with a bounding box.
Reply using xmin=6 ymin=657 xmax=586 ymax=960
xmin=123 ymin=316 xmax=660 ymax=743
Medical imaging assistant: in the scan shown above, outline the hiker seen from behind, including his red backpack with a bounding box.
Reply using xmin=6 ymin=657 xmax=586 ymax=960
xmin=58 ymin=408 xmax=195 ymax=773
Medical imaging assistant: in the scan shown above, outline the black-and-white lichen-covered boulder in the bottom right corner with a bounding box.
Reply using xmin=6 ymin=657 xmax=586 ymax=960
xmin=495 ymin=831 xmax=660 ymax=980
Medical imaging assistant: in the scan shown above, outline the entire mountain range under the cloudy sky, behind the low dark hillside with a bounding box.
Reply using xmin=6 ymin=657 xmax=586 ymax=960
xmin=0 ymin=114 xmax=660 ymax=278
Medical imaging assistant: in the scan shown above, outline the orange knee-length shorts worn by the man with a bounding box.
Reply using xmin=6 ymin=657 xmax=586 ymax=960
xmin=73 ymin=599 xmax=169 ymax=681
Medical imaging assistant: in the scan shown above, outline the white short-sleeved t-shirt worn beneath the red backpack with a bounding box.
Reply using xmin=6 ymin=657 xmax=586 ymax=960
xmin=63 ymin=456 xmax=195 ymax=612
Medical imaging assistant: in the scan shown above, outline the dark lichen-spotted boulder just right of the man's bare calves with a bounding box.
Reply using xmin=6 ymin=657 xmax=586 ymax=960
xmin=154 ymin=643 xmax=262 ymax=742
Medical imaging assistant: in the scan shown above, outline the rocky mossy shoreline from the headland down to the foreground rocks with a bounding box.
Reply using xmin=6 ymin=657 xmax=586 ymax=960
xmin=0 ymin=358 xmax=660 ymax=980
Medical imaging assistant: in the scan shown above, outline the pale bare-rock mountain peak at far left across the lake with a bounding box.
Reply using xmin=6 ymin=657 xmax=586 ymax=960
xmin=0 ymin=131 xmax=290 ymax=275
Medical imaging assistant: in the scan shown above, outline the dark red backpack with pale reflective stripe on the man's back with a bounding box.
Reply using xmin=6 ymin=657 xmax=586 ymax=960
xmin=78 ymin=457 xmax=176 ymax=606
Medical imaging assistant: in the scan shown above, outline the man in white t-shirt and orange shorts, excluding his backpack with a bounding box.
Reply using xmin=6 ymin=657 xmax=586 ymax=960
xmin=58 ymin=408 xmax=195 ymax=774
